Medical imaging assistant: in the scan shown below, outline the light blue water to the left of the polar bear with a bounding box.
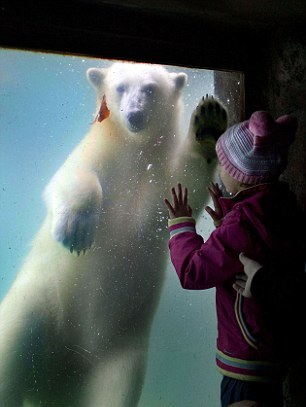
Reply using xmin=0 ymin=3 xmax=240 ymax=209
xmin=0 ymin=50 xmax=111 ymax=297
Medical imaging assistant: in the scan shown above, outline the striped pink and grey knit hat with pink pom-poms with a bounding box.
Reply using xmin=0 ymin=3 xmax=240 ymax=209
xmin=216 ymin=111 xmax=297 ymax=184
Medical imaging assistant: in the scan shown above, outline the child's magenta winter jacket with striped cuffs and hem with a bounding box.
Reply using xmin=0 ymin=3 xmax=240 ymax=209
xmin=169 ymin=183 xmax=303 ymax=382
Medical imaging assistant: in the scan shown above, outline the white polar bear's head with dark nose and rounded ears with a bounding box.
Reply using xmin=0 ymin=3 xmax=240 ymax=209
xmin=87 ymin=62 xmax=187 ymax=136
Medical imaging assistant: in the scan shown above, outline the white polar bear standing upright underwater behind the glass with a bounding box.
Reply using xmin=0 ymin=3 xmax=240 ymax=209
xmin=0 ymin=62 xmax=227 ymax=407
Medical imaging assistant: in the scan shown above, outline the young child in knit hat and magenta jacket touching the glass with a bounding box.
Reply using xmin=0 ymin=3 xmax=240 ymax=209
xmin=165 ymin=111 xmax=303 ymax=407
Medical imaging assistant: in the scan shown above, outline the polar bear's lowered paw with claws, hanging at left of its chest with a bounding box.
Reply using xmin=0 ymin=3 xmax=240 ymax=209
xmin=52 ymin=209 xmax=99 ymax=255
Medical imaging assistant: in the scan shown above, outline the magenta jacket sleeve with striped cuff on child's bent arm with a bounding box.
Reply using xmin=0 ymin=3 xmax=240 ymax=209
xmin=168 ymin=212 xmax=252 ymax=290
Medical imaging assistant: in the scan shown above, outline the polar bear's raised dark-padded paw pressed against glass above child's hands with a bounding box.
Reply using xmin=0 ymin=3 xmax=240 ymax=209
xmin=189 ymin=95 xmax=228 ymax=162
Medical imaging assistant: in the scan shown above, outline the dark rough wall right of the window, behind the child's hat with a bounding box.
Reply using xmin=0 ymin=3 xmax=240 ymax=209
xmin=246 ymin=32 xmax=306 ymax=214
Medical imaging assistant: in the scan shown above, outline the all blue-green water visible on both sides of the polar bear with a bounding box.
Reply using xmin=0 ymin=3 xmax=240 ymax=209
xmin=0 ymin=49 xmax=220 ymax=407
